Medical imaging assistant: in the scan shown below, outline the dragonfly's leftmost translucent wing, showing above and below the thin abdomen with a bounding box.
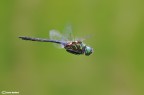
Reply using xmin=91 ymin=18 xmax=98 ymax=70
xmin=49 ymin=30 xmax=64 ymax=48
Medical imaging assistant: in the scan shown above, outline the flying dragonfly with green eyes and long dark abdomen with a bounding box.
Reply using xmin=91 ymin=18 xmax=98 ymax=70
xmin=19 ymin=28 xmax=93 ymax=56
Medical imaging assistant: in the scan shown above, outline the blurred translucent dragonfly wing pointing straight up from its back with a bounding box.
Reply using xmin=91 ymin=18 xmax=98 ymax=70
xmin=63 ymin=24 xmax=74 ymax=41
